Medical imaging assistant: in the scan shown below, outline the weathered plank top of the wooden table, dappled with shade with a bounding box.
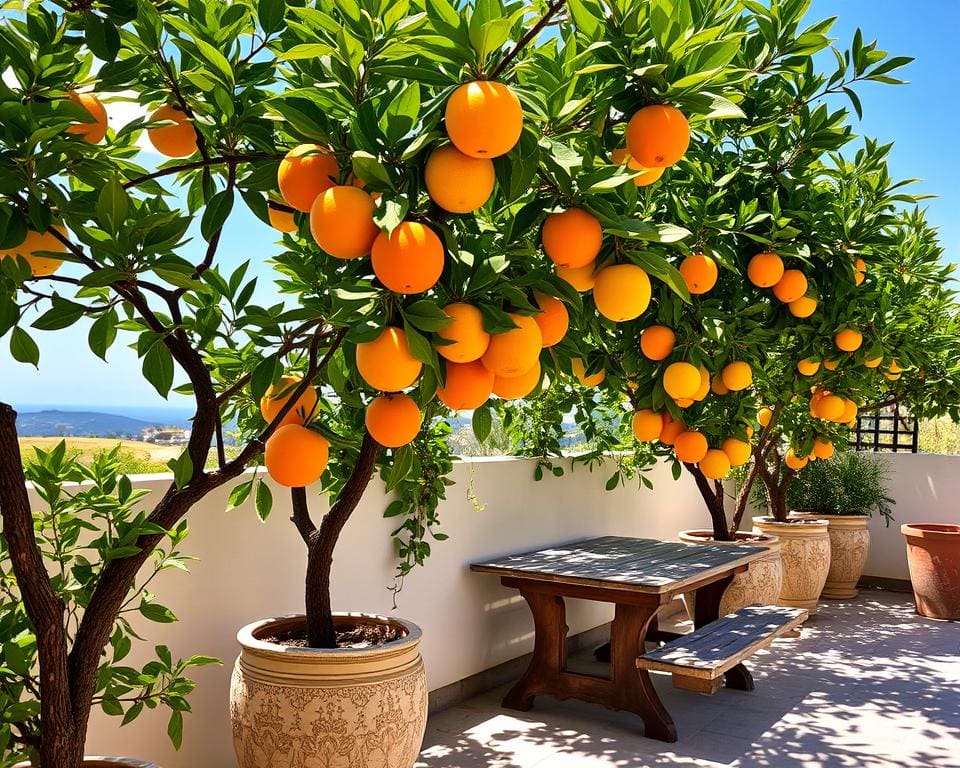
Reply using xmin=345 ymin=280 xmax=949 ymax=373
xmin=470 ymin=536 xmax=767 ymax=594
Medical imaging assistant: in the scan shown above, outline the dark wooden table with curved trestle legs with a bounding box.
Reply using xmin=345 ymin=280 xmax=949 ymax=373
xmin=470 ymin=536 xmax=767 ymax=742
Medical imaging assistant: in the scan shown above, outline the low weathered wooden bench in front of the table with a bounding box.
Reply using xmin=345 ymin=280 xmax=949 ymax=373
xmin=637 ymin=605 xmax=807 ymax=693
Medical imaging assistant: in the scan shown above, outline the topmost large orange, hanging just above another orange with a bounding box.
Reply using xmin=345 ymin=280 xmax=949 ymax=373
xmin=444 ymin=80 xmax=523 ymax=159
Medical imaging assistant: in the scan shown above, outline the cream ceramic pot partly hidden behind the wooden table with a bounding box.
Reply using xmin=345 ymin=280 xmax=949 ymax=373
xmin=680 ymin=529 xmax=783 ymax=619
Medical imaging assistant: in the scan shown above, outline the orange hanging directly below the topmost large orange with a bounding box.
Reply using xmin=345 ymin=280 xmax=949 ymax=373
xmin=423 ymin=144 xmax=497 ymax=213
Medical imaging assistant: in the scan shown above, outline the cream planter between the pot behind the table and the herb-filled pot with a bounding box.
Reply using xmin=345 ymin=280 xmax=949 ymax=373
xmin=753 ymin=517 xmax=830 ymax=615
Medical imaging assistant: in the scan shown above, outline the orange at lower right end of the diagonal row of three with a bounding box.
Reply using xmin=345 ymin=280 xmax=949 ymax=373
xmin=370 ymin=221 xmax=443 ymax=293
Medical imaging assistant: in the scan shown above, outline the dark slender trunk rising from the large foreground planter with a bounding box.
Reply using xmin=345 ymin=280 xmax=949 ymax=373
xmin=308 ymin=434 xmax=381 ymax=648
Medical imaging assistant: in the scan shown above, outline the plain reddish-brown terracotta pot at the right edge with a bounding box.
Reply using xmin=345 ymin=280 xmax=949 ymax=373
xmin=900 ymin=523 xmax=960 ymax=620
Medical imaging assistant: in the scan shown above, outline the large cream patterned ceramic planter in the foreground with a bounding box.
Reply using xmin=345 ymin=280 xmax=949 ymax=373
xmin=230 ymin=614 xmax=427 ymax=768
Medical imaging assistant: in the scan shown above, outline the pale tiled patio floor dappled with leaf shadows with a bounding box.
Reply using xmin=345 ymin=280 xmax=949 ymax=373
xmin=417 ymin=590 xmax=960 ymax=768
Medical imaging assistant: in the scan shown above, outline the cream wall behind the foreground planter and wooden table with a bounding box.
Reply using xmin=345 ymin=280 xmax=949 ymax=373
xmin=69 ymin=459 xmax=709 ymax=768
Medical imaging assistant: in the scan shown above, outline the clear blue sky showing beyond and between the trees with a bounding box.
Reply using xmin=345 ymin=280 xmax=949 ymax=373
xmin=0 ymin=0 xmax=960 ymax=409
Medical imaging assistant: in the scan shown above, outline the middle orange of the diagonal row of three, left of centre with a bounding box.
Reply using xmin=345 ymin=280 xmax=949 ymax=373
xmin=310 ymin=185 xmax=380 ymax=259
